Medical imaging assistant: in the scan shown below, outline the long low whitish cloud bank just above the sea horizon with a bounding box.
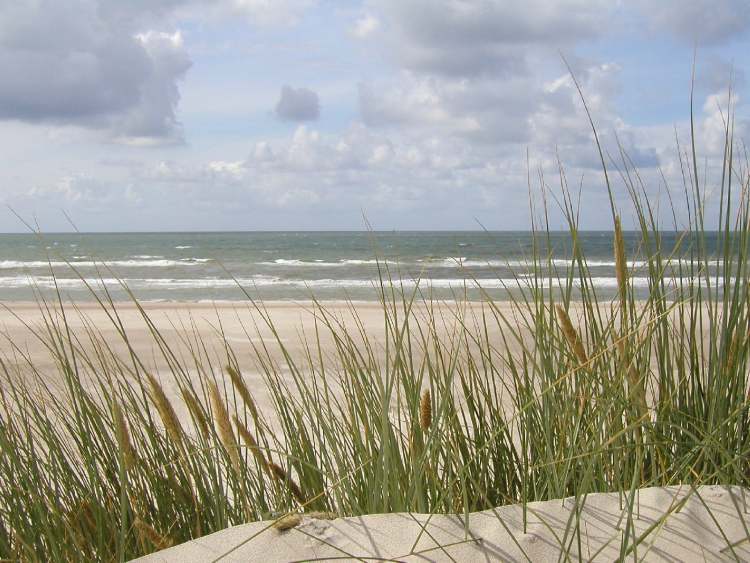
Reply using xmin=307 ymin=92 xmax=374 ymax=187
xmin=6 ymin=81 xmax=748 ymax=230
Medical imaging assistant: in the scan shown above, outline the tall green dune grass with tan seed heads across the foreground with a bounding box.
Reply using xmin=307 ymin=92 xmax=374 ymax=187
xmin=0 ymin=90 xmax=750 ymax=560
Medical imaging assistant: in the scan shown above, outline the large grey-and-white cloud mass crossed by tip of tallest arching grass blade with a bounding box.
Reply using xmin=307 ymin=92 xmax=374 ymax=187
xmin=359 ymin=0 xmax=659 ymax=185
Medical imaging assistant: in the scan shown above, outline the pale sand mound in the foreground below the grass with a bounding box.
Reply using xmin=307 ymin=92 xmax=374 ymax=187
xmin=138 ymin=486 xmax=750 ymax=563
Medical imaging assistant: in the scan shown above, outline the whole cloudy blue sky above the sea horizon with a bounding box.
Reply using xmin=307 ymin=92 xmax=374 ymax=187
xmin=0 ymin=0 xmax=750 ymax=232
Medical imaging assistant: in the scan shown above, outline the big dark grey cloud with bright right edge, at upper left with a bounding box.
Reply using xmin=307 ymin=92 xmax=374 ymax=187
xmin=0 ymin=0 xmax=190 ymax=142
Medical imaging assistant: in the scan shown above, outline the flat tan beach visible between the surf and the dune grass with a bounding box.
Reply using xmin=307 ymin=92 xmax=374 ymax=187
xmin=0 ymin=302 xmax=510 ymax=432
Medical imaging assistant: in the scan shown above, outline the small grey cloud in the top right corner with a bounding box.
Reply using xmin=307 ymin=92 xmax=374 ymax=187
xmin=634 ymin=0 xmax=750 ymax=46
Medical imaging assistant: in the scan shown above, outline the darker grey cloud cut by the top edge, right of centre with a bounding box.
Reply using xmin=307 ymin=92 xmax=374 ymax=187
xmin=371 ymin=0 xmax=613 ymax=77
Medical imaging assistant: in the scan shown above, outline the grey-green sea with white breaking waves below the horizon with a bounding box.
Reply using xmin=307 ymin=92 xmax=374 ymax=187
xmin=0 ymin=231 xmax=728 ymax=301
